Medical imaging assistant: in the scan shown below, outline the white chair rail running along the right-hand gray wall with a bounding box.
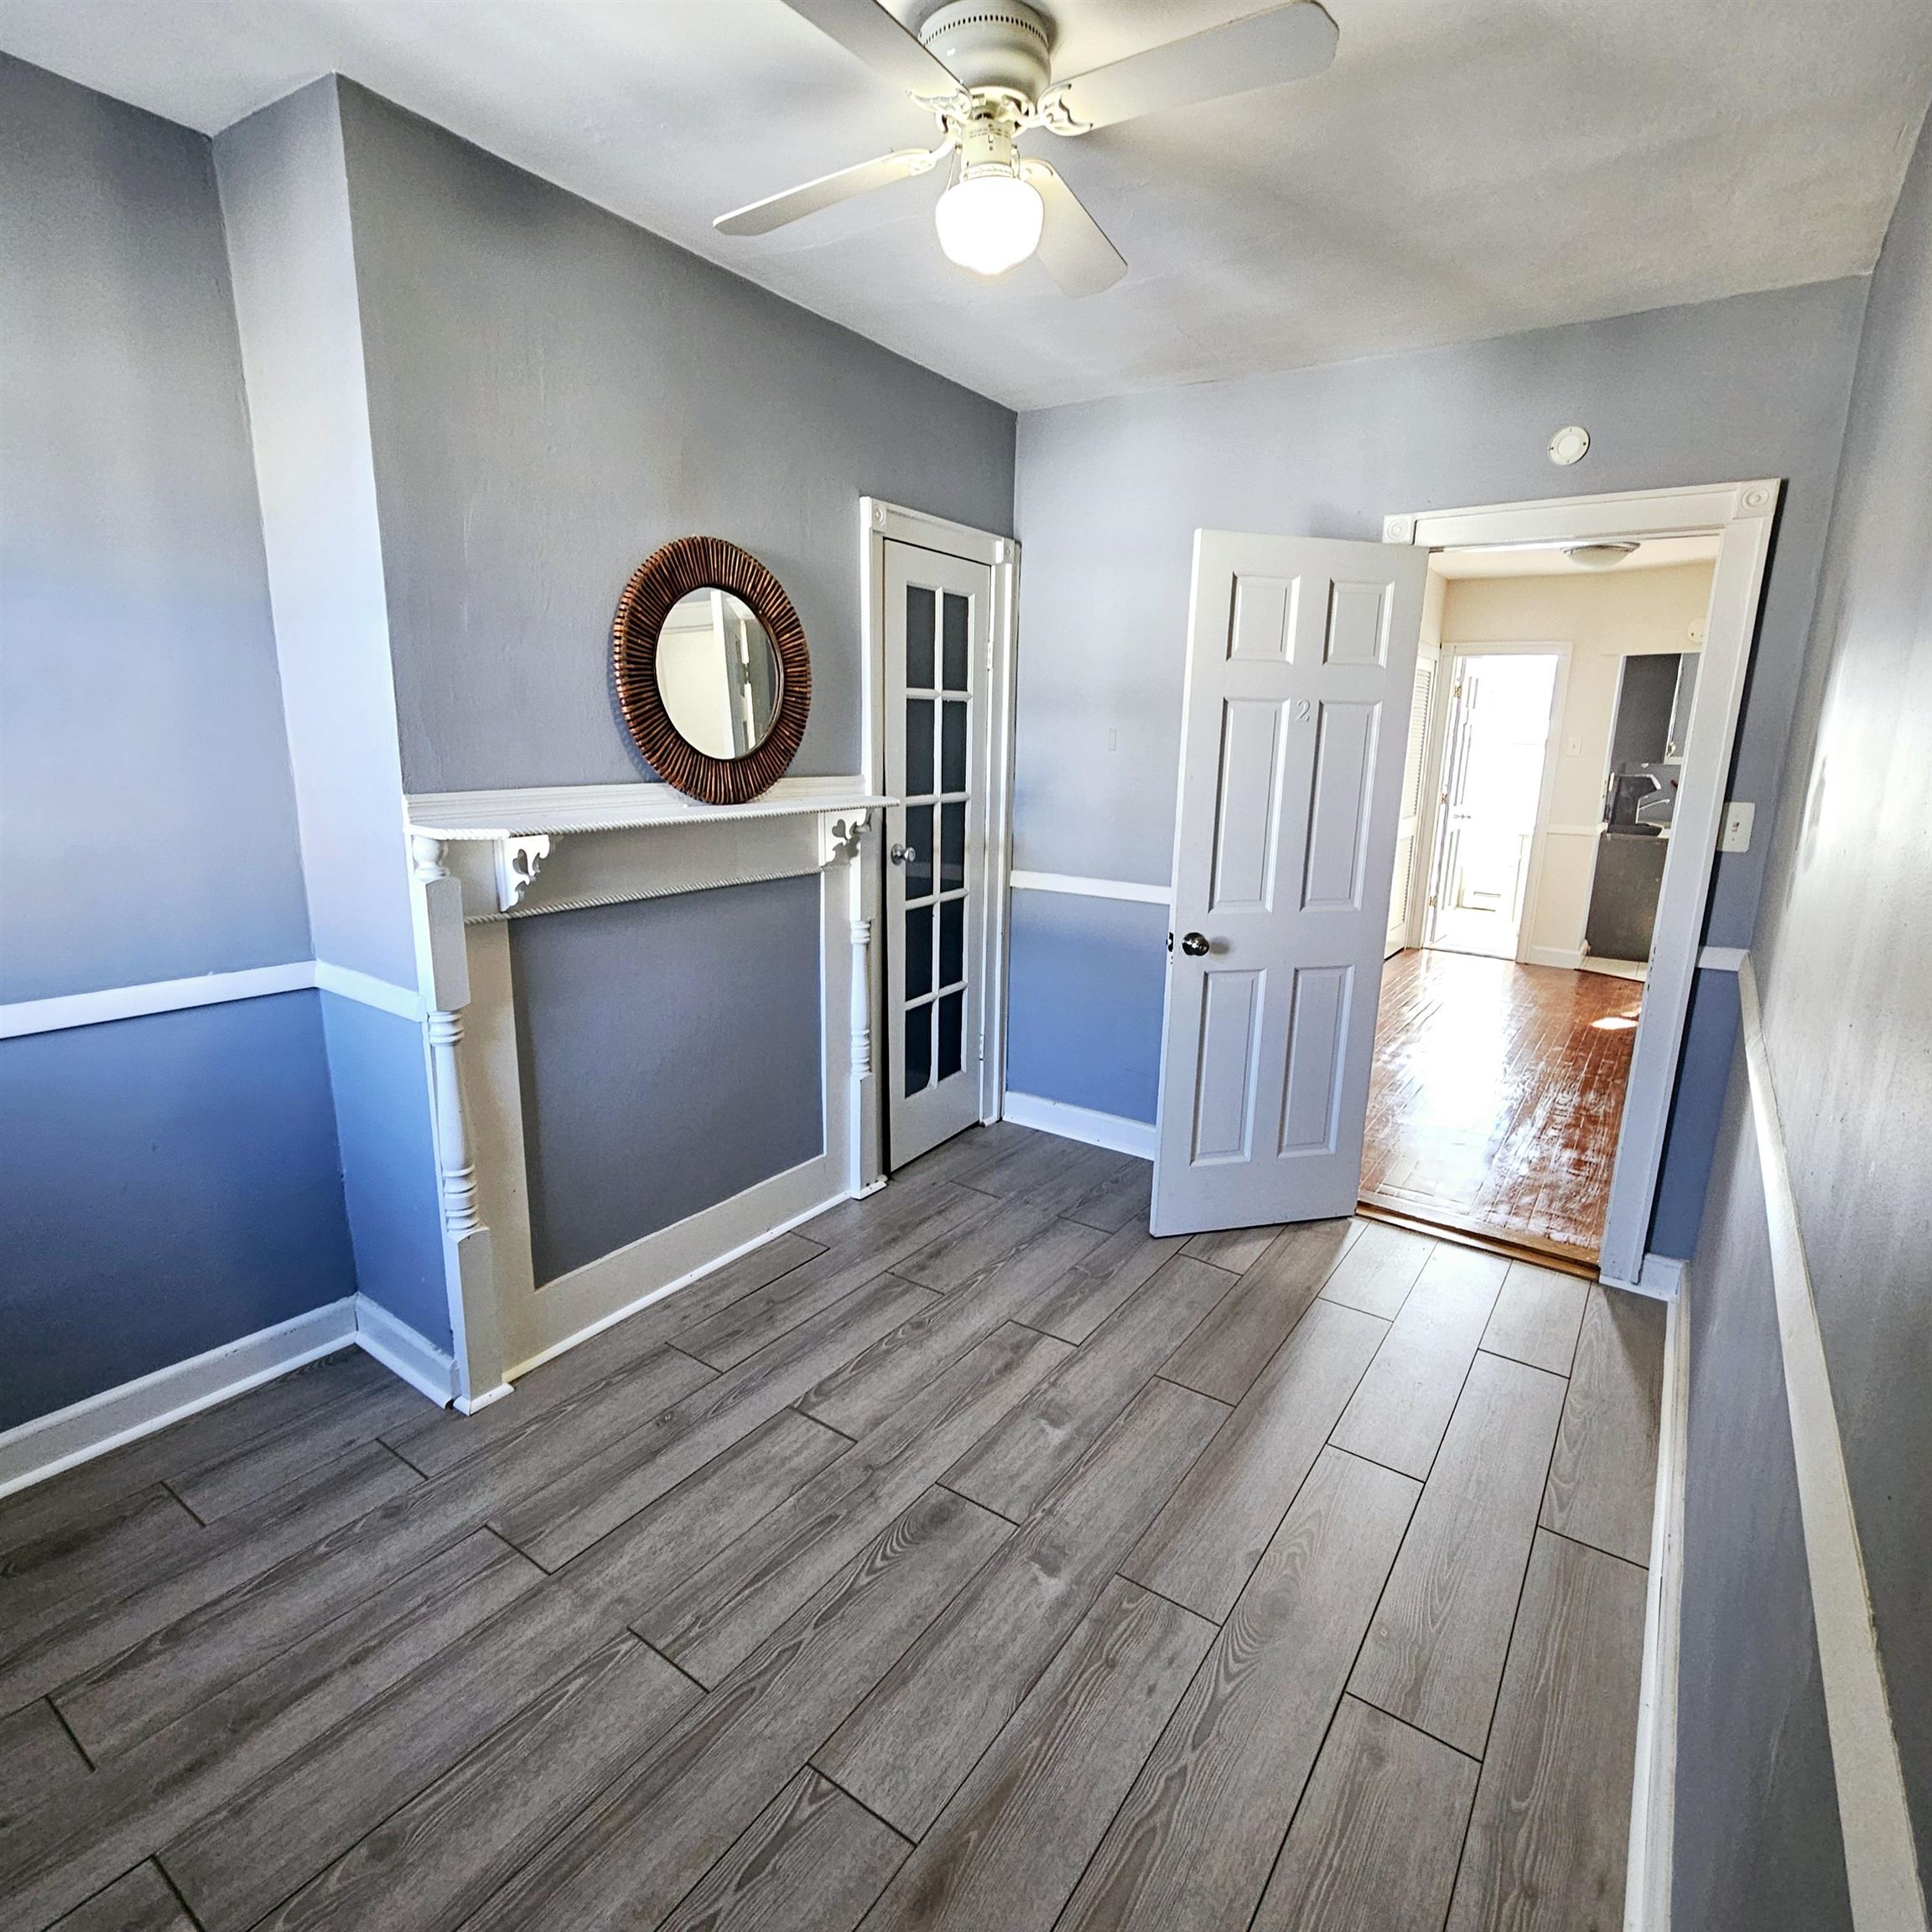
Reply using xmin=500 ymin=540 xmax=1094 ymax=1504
xmin=1737 ymin=958 xmax=1926 ymax=1932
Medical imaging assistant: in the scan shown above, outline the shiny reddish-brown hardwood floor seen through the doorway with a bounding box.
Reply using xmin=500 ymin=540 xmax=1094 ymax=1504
xmin=1362 ymin=948 xmax=1644 ymax=1262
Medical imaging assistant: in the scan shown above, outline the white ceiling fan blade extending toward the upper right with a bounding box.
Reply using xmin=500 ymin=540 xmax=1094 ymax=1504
xmin=1051 ymin=0 xmax=1341 ymax=133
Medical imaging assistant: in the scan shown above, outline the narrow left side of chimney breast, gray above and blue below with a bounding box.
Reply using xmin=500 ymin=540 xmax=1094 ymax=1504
xmin=215 ymin=79 xmax=450 ymax=1347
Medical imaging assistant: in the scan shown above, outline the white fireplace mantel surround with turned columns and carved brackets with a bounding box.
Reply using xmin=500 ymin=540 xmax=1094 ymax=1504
xmin=406 ymin=776 xmax=891 ymax=1409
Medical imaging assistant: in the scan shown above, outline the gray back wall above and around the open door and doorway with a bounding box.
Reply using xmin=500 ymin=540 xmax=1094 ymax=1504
xmin=1012 ymin=282 xmax=1864 ymax=1252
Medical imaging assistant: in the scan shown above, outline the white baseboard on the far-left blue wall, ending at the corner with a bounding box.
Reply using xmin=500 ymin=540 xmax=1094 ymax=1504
xmin=0 ymin=1298 xmax=359 ymax=1495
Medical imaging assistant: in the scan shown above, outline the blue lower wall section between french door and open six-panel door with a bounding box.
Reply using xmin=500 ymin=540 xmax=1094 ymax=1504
xmin=1006 ymin=891 xmax=1167 ymax=1123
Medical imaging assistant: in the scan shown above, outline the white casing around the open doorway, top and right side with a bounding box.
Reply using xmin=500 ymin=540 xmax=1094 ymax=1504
xmin=1381 ymin=477 xmax=1784 ymax=1289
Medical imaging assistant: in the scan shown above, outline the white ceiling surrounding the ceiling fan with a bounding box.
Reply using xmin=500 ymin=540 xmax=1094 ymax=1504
xmin=0 ymin=0 xmax=1932 ymax=408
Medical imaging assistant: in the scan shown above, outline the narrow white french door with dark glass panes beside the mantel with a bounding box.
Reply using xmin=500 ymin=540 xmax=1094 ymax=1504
xmin=885 ymin=541 xmax=993 ymax=1167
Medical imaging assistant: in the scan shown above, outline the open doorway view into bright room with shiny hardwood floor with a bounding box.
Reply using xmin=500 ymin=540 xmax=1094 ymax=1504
xmin=1362 ymin=535 xmax=1717 ymax=1271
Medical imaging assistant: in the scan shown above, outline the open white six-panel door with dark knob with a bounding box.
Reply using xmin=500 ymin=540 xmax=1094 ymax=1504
xmin=1153 ymin=529 xmax=1428 ymax=1234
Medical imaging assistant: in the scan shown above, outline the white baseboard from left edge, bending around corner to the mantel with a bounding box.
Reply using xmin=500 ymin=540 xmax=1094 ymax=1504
xmin=0 ymin=1295 xmax=456 ymax=1495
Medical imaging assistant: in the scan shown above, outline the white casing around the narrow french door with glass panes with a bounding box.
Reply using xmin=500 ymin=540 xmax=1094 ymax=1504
xmin=858 ymin=496 xmax=1021 ymax=1145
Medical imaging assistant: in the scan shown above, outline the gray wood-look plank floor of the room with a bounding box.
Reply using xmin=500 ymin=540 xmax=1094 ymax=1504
xmin=0 ymin=1126 xmax=1661 ymax=1932
